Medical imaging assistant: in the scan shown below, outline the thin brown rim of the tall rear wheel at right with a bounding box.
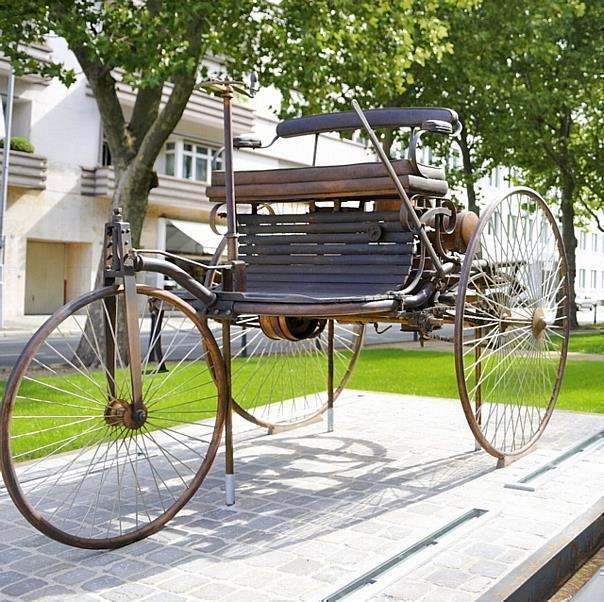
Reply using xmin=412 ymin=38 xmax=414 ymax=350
xmin=454 ymin=187 xmax=569 ymax=458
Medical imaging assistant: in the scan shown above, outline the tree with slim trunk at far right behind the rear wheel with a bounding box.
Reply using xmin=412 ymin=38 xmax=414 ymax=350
xmin=488 ymin=0 xmax=604 ymax=327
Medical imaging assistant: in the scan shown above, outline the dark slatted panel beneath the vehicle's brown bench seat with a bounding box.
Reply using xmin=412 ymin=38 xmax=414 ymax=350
xmin=238 ymin=211 xmax=413 ymax=299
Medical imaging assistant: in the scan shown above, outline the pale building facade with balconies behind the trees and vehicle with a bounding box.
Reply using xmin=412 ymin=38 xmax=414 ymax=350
xmin=0 ymin=39 xmax=604 ymax=318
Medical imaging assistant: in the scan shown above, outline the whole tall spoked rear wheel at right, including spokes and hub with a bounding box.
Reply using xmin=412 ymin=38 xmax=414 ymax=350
xmin=454 ymin=188 xmax=569 ymax=458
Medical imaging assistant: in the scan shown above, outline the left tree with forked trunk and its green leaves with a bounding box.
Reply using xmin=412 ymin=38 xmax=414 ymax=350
xmin=0 ymin=0 xmax=258 ymax=246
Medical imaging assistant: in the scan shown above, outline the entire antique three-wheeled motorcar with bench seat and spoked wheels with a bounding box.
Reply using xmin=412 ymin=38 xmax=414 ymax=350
xmin=1 ymin=81 xmax=568 ymax=548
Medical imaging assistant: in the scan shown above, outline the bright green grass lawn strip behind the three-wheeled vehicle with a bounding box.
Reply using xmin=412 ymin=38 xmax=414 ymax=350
xmin=0 ymin=342 xmax=604 ymax=460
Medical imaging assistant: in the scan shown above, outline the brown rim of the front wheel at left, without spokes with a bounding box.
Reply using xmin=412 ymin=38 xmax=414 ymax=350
xmin=0 ymin=285 xmax=226 ymax=549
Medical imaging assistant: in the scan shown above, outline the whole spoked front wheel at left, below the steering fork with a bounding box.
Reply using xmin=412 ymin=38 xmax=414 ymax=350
xmin=1 ymin=286 xmax=225 ymax=548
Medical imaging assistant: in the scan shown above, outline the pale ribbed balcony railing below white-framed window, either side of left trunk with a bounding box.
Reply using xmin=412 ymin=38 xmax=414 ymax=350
xmin=82 ymin=166 xmax=210 ymax=209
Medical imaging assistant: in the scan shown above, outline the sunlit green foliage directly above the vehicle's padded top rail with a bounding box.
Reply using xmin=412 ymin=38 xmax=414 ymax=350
xmin=251 ymin=0 xmax=474 ymax=116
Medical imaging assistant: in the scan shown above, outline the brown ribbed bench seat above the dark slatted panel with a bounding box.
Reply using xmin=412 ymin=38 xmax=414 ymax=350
xmin=206 ymin=159 xmax=448 ymax=203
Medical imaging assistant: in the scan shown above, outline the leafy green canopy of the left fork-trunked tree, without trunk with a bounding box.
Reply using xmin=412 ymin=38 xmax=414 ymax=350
xmin=0 ymin=0 xmax=257 ymax=88
